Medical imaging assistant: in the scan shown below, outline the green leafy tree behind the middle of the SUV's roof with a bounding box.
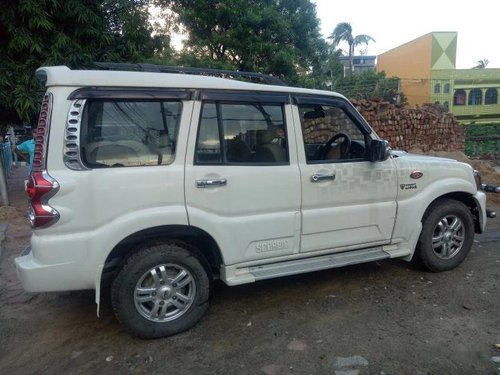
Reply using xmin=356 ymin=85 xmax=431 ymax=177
xmin=159 ymin=0 xmax=326 ymax=82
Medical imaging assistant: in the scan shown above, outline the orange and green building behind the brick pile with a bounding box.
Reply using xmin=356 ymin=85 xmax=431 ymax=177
xmin=377 ymin=32 xmax=500 ymax=124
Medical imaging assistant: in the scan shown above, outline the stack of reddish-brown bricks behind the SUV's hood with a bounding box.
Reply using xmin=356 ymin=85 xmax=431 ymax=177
xmin=352 ymin=100 xmax=465 ymax=152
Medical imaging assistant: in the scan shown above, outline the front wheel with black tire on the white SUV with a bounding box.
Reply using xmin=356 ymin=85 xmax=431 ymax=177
xmin=415 ymin=199 xmax=474 ymax=272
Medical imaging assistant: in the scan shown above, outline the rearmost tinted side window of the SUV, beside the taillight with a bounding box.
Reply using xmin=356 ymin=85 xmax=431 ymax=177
xmin=80 ymin=100 xmax=182 ymax=168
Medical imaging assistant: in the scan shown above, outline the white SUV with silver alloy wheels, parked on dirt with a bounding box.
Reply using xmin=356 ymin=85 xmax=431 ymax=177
xmin=16 ymin=66 xmax=486 ymax=338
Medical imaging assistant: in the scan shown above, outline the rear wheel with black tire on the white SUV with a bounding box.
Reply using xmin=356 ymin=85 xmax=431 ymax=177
xmin=111 ymin=242 xmax=210 ymax=339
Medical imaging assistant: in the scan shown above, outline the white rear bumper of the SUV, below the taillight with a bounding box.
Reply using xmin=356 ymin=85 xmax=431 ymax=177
xmin=15 ymin=247 xmax=94 ymax=292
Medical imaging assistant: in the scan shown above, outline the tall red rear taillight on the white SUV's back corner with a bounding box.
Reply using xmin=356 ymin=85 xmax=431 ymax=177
xmin=26 ymin=93 xmax=59 ymax=228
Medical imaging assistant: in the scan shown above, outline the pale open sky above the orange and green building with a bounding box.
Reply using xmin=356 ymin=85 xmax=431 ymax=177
xmin=311 ymin=0 xmax=500 ymax=69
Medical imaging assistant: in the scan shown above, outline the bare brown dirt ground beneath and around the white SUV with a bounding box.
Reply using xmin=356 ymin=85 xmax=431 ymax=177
xmin=0 ymin=157 xmax=500 ymax=375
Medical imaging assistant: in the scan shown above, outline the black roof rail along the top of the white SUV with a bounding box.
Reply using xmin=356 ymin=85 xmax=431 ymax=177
xmin=94 ymin=62 xmax=286 ymax=86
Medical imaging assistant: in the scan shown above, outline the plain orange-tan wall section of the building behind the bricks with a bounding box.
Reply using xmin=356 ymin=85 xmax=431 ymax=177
xmin=377 ymin=33 xmax=432 ymax=105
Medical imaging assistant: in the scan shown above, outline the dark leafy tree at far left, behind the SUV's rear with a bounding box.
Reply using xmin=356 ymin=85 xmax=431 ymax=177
xmin=0 ymin=0 xmax=170 ymax=125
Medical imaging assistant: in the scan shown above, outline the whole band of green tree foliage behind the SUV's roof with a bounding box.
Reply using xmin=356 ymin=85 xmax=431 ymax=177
xmin=0 ymin=0 xmax=406 ymax=131
